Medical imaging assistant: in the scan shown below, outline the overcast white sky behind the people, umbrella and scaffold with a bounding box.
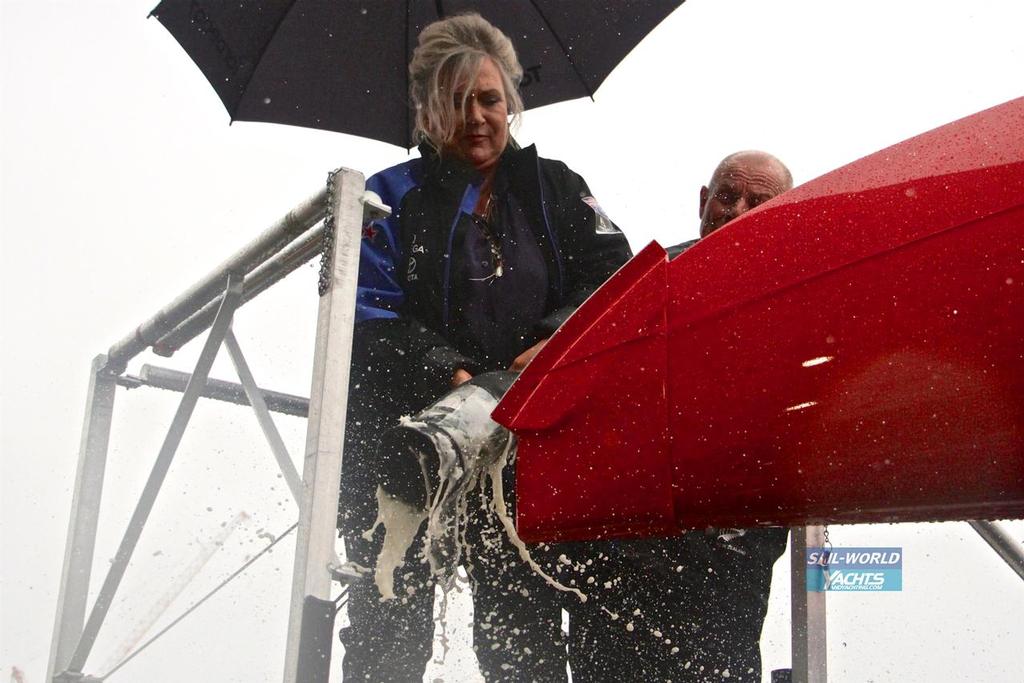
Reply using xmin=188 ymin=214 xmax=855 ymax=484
xmin=0 ymin=0 xmax=1024 ymax=683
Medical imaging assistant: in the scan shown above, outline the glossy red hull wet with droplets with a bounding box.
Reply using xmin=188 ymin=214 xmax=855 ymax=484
xmin=495 ymin=98 xmax=1024 ymax=541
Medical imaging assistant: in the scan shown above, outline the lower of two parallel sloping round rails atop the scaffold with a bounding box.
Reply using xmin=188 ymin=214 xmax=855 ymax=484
xmin=153 ymin=223 xmax=326 ymax=356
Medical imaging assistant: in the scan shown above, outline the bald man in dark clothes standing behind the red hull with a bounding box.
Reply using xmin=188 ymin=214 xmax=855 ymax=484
xmin=569 ymin=151 xmax=793 ymax=683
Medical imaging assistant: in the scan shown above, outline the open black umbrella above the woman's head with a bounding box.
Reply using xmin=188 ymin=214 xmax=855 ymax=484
xmin=153 ymin=0 xmax=683 ymax=147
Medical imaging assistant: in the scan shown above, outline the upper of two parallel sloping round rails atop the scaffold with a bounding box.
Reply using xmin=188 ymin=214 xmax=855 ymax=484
xmin=108 ymin=191 xmax=326 ymax=374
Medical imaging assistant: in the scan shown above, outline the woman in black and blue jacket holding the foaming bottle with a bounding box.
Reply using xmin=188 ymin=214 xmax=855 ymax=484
xmin=341 ymin=14 xmax=630 ymax=681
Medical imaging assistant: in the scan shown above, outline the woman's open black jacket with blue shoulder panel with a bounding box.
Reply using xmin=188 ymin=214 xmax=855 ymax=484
xmin=341 ymin=145 xmax=632 ymax=530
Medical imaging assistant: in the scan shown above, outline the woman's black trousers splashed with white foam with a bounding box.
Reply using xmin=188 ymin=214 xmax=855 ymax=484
xmin=340 ymin=481 xmax=567 ymax=683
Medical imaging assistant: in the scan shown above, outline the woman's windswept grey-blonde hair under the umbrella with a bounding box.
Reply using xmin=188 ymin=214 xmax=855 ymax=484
xmin=409 ymin=12 xmax=522 ymax=150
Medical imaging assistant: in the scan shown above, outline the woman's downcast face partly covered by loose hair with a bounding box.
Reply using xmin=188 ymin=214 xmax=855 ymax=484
xmin=452 ymin=57 xmax=509 ymax=171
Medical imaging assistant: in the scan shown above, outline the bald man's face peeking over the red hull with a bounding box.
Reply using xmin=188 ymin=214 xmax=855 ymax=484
xmin=700 ymin=156 xmax=788 ymax=238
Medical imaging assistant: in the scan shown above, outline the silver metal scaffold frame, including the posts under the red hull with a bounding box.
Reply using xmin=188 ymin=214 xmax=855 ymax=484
xmin=46 ymin=169 xmax=1024 ymax=683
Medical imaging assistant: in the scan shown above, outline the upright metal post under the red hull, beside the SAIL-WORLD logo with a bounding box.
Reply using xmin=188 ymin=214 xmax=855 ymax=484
xmin=790 ymin=526 xmax=828 ymax=683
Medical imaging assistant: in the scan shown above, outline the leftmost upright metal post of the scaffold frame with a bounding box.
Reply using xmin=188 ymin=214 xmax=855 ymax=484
xmin=46 ymin=354 xmax=117 ymax=681
